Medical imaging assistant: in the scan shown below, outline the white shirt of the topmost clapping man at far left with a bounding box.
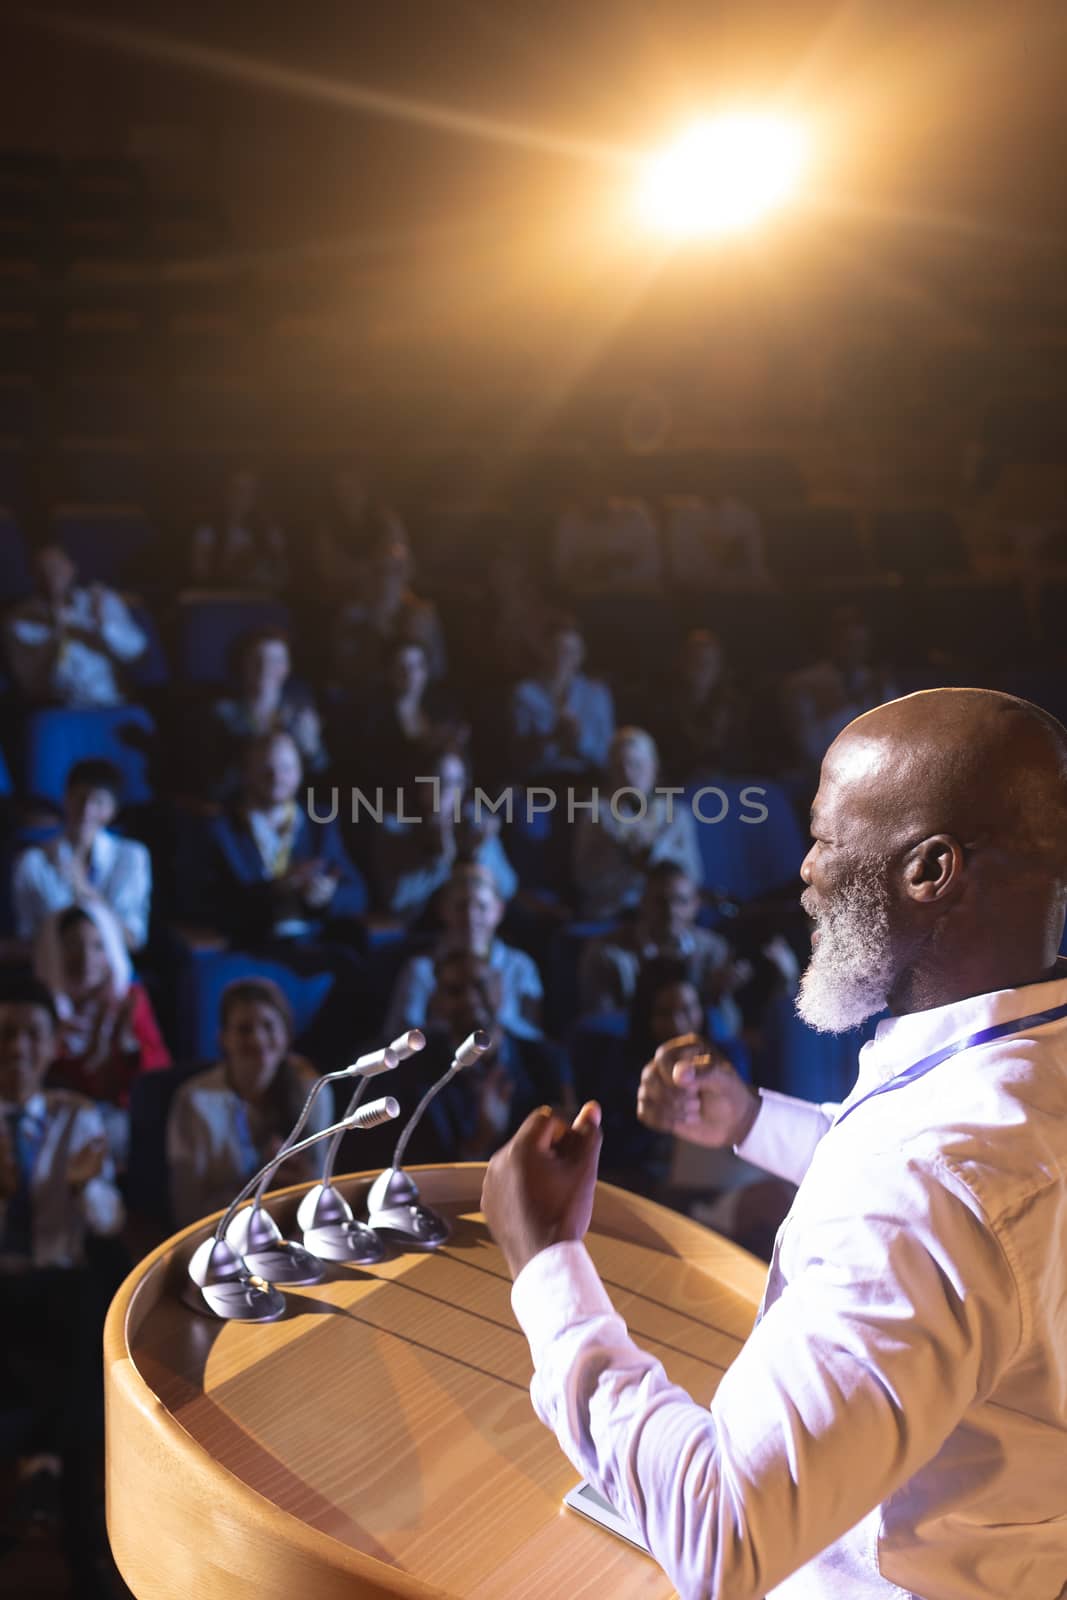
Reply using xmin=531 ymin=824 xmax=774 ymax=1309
xmin=5 ymin=584 xmax=149 ymax=707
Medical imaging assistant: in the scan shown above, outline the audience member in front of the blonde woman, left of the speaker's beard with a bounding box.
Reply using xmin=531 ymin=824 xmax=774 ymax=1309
xmin=579 ymin=861 xmax=749 ymax=1032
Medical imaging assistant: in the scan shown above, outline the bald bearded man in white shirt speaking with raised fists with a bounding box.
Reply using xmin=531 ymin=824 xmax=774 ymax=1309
xmin=483 ymin=690 xmax=1067 ymax=1600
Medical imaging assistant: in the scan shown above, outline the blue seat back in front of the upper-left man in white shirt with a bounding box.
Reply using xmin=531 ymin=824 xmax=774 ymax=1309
xmin=21 ymin=706 xmax=155 ymax=805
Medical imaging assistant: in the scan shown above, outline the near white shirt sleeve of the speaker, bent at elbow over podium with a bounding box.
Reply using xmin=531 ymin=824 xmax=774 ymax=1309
xmin=512 ymin=1154 xmax=1021 ymax=1600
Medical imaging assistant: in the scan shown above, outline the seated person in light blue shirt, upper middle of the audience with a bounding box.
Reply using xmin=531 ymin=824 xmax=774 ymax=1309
xmin=509 ymin=613 xmax=614 ymax=779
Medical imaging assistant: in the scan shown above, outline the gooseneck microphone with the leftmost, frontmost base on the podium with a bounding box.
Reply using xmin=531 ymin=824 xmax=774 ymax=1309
xmin=182 ymin=1096 xmax=400 ymax=1322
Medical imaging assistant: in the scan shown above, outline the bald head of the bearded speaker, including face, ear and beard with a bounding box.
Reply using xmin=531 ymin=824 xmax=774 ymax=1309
xmin=800 ymin=690 xmax=1067 ymax=1026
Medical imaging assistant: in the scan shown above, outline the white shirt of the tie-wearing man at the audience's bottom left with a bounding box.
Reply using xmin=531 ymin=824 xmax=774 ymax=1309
xmin=0 ymin=1090 xmax=126 ymax=1272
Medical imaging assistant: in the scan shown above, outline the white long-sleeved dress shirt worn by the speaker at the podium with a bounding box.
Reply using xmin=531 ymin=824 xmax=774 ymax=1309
xmin=514 ymin=963 xmax=1067 ymax=1600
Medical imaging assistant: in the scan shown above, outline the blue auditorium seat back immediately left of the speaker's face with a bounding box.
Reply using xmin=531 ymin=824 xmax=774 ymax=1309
xmin=687 ymin=778 xmax=808 ymax=901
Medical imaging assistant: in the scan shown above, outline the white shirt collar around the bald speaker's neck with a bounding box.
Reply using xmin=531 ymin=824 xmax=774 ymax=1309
xmin=859 ymin=957 xmax=1067 ymax=1085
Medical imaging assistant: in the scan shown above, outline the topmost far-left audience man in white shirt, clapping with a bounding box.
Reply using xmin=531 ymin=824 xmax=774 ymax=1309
xmin=3 ymin=539 xmax=149 ymax=710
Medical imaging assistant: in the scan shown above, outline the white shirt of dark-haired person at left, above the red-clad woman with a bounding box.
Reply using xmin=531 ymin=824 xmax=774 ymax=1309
xmin=13 ymin=829 xmax=152 ymax=950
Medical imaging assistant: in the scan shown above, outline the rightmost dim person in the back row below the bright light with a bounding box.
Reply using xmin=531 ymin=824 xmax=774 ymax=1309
xmin=665 ymin=480 xmax=768 ymax=589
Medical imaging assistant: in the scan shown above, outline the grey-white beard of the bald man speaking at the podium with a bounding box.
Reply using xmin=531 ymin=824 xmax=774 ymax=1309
xmin=797 ymin=862 xmax=894 ymax=1034
